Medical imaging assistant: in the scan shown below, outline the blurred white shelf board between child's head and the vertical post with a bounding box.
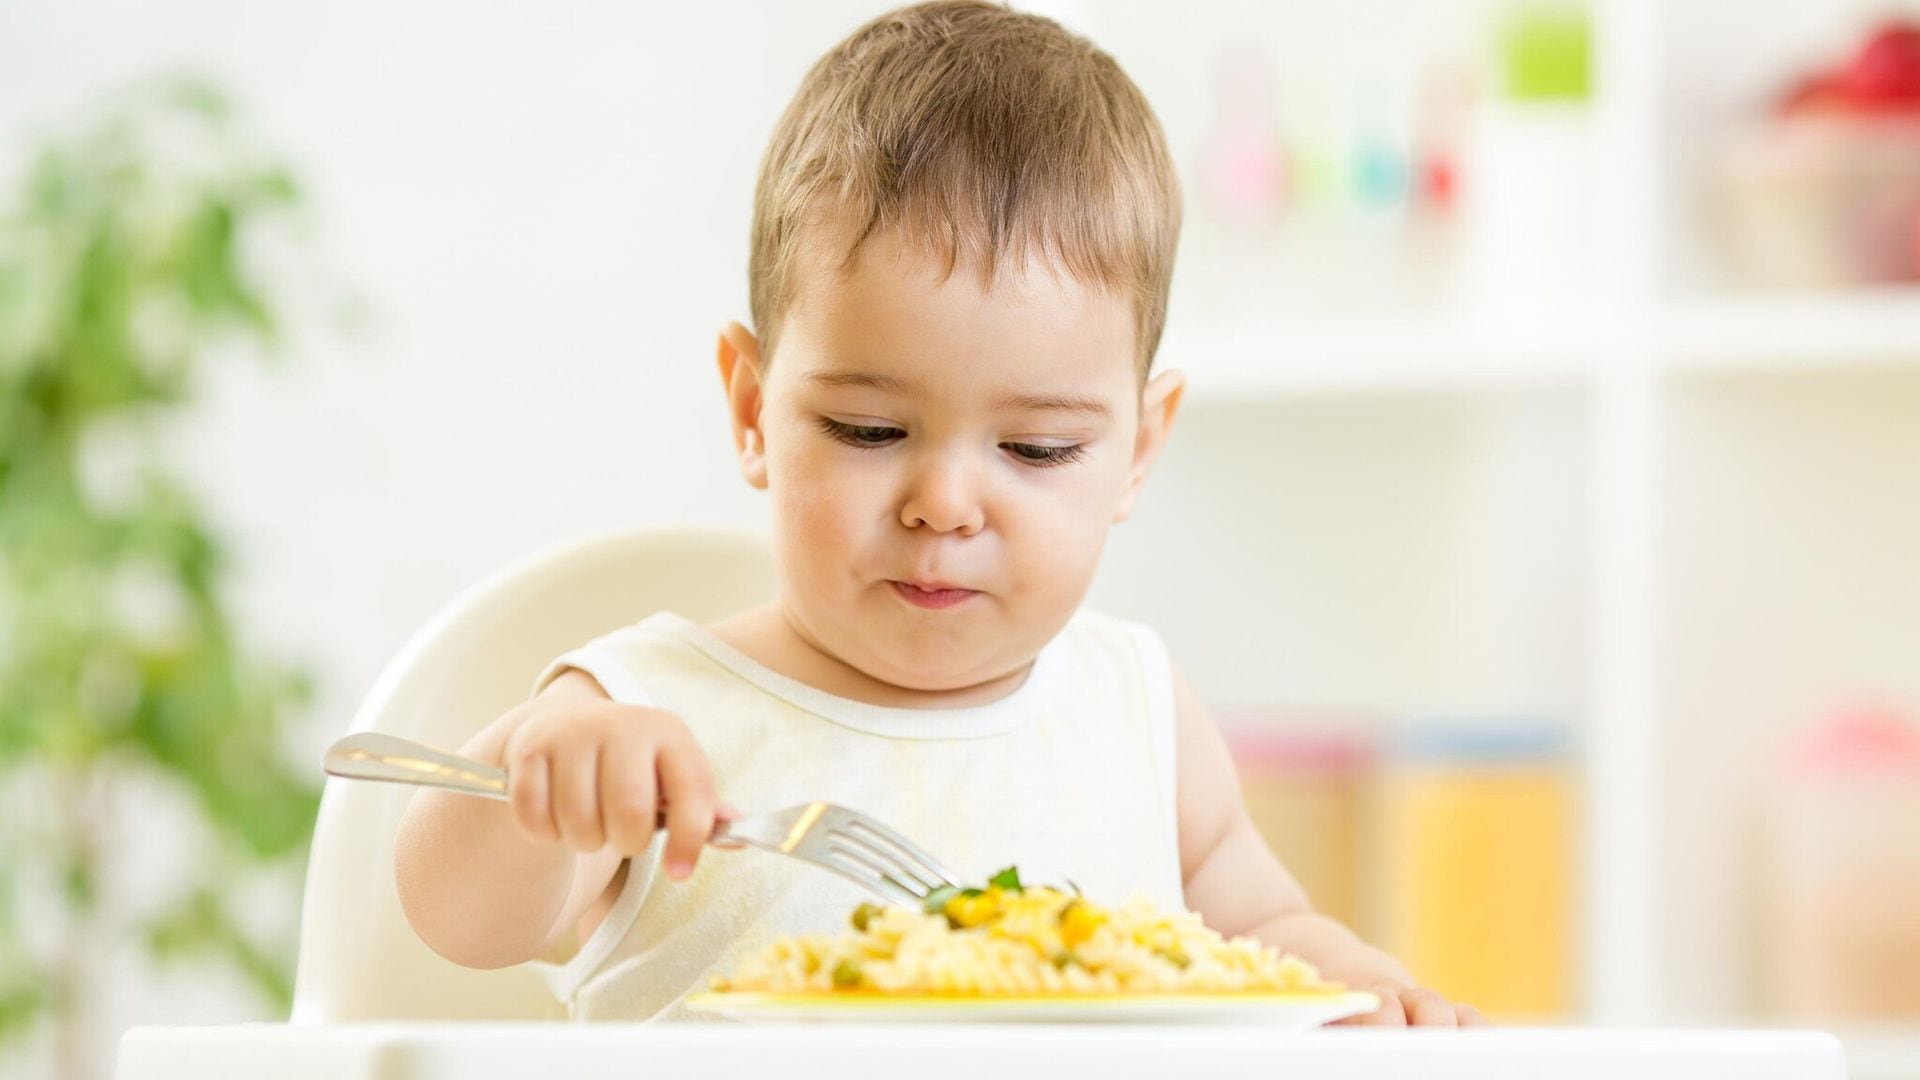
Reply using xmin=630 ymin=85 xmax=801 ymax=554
xmin=1156 ymin=315 xmax=1586 ymax=402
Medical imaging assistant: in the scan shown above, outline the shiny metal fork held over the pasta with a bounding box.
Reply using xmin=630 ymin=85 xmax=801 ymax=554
xmin=326 ymin=732 xmax=975 ymax=905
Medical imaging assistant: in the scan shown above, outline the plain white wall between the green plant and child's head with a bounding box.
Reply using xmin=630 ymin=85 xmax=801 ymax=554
xmin=0 ymin=0 xmax=921 ymax=749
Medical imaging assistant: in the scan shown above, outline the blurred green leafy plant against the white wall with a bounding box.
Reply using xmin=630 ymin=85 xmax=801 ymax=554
xmin=0 ymin=79 xmax=319 ymax=1074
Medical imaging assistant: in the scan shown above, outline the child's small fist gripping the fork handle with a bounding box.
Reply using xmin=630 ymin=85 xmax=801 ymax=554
xmin=501 ymin=696 xmax=733 ymax=878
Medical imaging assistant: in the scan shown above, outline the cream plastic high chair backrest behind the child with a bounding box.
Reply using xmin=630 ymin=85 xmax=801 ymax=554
xmin=292 ymin=527 xmax=774 ymax=1024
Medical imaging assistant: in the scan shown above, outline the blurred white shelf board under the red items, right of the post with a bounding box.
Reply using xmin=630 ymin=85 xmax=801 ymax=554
xmin=1659 ymin=288 xmax=1920 ymax=375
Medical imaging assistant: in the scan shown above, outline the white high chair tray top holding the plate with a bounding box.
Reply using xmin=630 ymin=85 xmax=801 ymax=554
xmin=117 ymin=1024 xmax=1845 ymax=1080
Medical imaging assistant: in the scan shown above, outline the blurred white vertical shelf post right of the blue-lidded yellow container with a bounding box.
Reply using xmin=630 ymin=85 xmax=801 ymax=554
xmin=1576 ymin=0 xmax=1667 ymax=1024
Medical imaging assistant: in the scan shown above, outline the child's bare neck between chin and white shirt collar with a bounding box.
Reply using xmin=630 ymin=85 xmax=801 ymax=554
xmin=707 ymin=600 xmax=1033 ymax=709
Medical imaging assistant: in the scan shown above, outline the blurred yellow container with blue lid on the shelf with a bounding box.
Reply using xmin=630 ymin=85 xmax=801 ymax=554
xmin=1369 ymin=728 xmax=1574 ymax=1020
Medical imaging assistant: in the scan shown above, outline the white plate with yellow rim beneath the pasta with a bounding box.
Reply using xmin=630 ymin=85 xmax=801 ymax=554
xmin=687 ymin=992 xmax=1380 ymax=1030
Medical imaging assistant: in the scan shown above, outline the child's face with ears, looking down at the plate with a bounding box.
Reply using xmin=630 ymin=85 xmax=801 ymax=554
xmin=720 ymin=234 xmax=1183 ymax=690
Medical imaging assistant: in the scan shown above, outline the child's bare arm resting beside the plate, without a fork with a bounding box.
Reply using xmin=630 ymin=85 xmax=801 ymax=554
xmin=1173 ymin=671 xmax=1480 ymax=1024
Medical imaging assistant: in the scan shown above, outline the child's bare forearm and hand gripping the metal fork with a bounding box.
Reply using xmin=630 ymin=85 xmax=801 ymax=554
xmin=394 ymin=671 xmax=716 ymax=967
